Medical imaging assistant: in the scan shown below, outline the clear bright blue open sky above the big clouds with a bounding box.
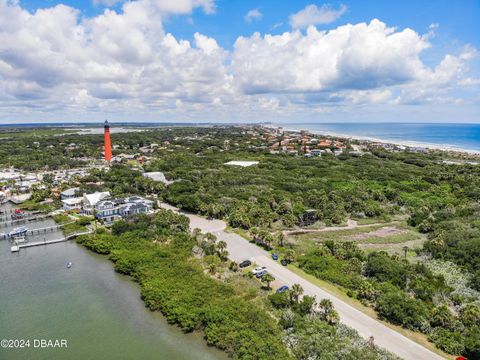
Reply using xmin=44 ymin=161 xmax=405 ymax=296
xmin=20 ymin=0 xmax=480 ymax=48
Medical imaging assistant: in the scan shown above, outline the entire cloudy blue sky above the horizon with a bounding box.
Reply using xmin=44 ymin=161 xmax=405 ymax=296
xmin=0 ymin=0 xmax=480 ymax=124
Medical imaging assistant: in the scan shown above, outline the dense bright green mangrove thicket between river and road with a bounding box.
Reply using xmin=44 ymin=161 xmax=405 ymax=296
xmin=78 ymin=210 xmax=290 ymax=359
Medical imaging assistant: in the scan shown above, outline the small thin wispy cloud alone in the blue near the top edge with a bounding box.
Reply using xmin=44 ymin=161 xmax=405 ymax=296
xmin=290 ymin=4 xmax=347 ymax=29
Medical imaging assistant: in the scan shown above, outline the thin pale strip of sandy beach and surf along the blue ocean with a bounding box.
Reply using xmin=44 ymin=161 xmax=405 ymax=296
xmin=274 ymin=125 xmax=480 ymax=155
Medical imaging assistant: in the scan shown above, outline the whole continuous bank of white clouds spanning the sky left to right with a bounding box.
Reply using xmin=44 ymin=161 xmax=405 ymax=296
xmin=0 ymin=0 xmax=478 ymax=119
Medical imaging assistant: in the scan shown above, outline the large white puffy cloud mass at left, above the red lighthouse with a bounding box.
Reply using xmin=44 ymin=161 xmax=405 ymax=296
xmin=0 ymin=1 xmax=226 ymax=107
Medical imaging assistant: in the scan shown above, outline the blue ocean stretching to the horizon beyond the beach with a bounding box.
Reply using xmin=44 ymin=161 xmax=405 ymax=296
xmin=280 ymin=123 xmax=480 ymax=151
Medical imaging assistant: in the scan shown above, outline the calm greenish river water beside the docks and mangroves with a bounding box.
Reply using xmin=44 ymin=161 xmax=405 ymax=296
xmin=0 ymin=205 xmax=226 ymax=360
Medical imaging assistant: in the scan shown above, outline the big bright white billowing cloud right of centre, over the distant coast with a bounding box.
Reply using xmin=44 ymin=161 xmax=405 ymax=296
xmin=232 ymin=20 xmax=429 ymax=94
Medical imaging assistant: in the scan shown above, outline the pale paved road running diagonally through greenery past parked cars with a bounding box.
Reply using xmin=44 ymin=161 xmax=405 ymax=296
xmin=162 ymin=204 xmax=443 ymax=360
